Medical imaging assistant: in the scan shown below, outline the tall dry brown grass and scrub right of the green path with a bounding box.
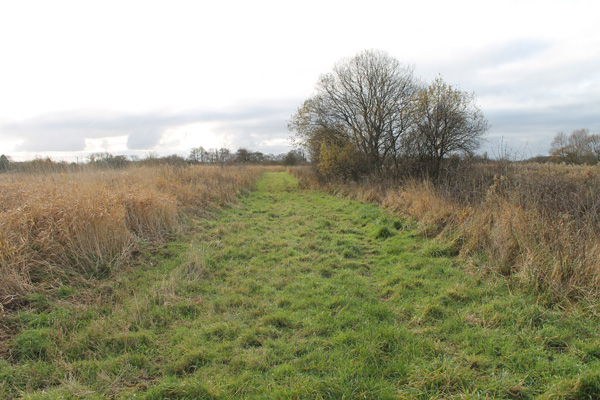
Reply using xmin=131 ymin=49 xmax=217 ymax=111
xmin=290 ymin=163 xmax=600 ymax=299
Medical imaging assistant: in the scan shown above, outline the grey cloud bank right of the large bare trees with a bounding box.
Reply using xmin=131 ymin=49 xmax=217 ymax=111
xmin=417 ymin=38 xmax=600 ymax=157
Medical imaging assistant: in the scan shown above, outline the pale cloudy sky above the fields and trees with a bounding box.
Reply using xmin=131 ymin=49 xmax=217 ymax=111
xmin=0 ymin=0 xmax=600 ymax=161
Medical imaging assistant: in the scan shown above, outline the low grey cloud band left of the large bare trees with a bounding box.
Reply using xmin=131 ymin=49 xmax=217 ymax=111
xmin=0 ymin=99 xmax=300 ymax=152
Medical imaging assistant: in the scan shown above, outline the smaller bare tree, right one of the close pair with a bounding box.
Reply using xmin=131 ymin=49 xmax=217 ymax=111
xmin=410 ymin=77 xmax=488 ymax=176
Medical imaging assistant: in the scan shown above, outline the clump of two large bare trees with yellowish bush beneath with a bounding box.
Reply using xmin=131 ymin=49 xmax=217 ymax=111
xmin=288 ymin=50 xmax=488 ymax=179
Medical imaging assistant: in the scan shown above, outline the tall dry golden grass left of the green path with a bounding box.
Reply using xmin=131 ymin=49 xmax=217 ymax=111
xmin=0 ymin=166 xmax=264 ymax=302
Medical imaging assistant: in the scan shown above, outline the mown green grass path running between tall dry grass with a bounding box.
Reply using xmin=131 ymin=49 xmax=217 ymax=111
xmin=0 ymin=173 xmax=600 ymax=399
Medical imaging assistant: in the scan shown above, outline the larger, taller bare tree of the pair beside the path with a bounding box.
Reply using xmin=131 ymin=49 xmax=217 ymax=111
xmin=289 ymin=50 xmax=418 ymax=177
